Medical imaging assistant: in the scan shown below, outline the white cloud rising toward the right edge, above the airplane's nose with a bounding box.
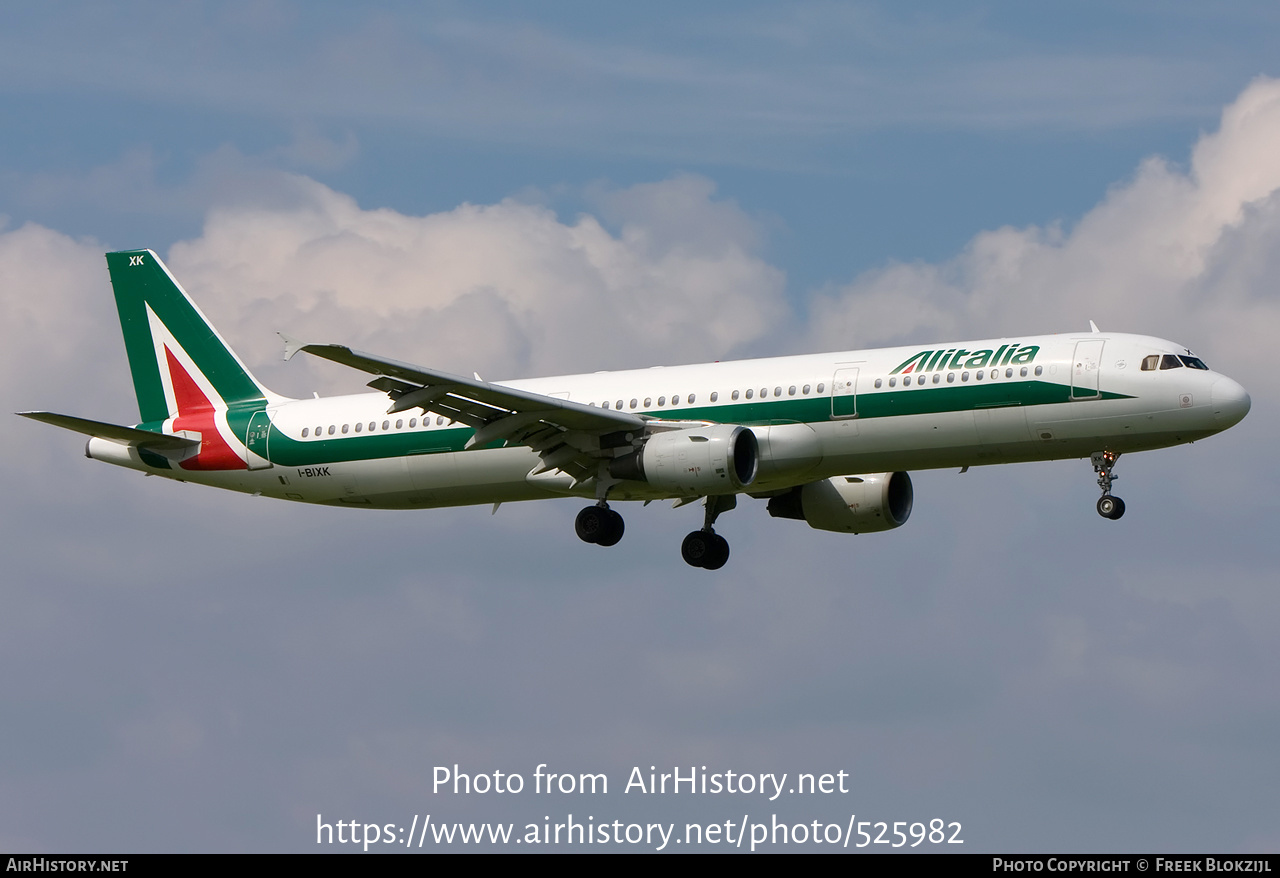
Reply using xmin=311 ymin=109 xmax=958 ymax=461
xmin=810 ymin=78 xmax=1280 ymax=389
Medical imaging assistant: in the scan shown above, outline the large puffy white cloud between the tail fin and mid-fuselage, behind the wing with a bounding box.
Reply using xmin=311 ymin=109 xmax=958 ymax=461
xmin=160 ymin=171 xmax=786 ymax=391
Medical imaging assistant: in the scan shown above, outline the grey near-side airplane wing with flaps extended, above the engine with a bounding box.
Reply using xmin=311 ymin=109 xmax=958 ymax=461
xmin=285 ymin=337 xmax=649 ymax=481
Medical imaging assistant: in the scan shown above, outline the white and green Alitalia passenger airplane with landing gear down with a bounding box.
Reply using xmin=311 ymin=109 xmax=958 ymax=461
xmin=18 ymin=250 xmax=1251 ymax=570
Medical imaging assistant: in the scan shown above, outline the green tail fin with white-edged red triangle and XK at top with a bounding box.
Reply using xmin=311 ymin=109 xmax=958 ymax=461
xmin=106 ymin=250 xmax=274 ymax=424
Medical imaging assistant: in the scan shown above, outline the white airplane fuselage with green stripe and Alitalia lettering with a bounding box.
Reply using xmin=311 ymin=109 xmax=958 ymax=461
xmin=88 ymin=333 xmax=1249 ymax=508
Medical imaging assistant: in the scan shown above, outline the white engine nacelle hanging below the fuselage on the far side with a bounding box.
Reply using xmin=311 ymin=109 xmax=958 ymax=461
xmin=769 ymin=472 xmax=914 ymax=534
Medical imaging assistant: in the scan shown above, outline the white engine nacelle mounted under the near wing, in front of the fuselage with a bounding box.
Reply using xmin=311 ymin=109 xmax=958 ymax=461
xmin=609 ymin=424 xmax=760 ymax=495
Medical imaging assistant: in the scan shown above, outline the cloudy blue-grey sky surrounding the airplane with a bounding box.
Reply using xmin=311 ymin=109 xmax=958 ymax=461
xmin=0 ymin=0 xmax=1280 ymax=854
